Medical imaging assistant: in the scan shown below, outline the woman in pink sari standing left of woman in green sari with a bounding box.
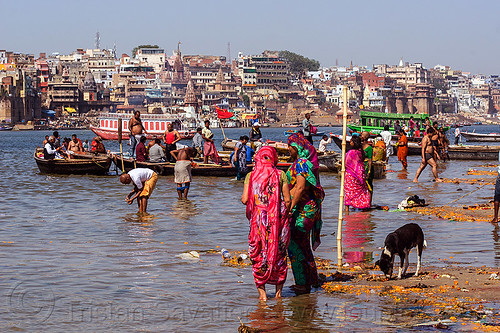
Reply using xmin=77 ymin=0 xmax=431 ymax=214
xmin=241 ymin=146 xmax=292 ymax=301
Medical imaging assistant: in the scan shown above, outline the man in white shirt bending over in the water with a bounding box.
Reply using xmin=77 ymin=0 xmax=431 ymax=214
xmin=120 ymin=168 xmax=158 ymax=213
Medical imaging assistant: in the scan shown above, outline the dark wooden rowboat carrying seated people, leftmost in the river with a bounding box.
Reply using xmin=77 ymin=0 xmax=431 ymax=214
xmin=33 ymin=148 xmax=112 ymax=175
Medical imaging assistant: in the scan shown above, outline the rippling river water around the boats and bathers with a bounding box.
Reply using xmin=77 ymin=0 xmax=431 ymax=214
xmin=0 ymin=126 xmax=500 ymax=332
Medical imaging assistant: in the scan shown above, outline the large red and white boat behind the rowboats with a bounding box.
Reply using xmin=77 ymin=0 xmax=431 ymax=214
xmin=90 ymin=113 xmax=196 ymax=140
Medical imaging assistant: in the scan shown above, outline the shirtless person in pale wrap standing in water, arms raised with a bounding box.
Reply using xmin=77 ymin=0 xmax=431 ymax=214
xmin=170 ymin=147 xmax=196 ymax=199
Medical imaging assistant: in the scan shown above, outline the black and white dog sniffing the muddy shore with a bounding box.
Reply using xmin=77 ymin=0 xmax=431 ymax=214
xmin=375 ymin=223 xmax=427 ymax=279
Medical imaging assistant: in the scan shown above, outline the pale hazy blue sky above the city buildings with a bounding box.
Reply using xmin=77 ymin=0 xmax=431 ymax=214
xmin=0 ymin=0 xmax=500 ymax=74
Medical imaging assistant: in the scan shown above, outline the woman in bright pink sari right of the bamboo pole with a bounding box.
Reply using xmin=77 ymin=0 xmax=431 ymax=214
xmin=344 ymin=136 xmax=371 ymax=212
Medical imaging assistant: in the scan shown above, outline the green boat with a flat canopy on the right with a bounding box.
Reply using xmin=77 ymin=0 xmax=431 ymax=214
xmin=347 ymin=111 xmax=450 ymax=135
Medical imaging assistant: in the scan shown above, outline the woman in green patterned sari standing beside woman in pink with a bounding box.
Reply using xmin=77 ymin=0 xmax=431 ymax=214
xmin=286 ymin=133 xmax=325 ymax=294
